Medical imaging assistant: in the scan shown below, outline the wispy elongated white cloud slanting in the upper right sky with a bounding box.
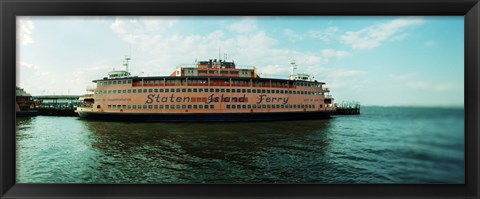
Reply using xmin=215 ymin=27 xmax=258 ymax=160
xmin=340 ymin=17 xmax=423 ymax=49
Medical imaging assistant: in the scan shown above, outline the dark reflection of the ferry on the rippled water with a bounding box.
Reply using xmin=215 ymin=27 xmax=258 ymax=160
xmin=82 ymin=120 xmax=329 ymax=183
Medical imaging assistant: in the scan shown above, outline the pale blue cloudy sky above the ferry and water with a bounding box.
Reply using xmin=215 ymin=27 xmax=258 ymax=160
xmin=16 ymin=16 xmax=464 ymax=107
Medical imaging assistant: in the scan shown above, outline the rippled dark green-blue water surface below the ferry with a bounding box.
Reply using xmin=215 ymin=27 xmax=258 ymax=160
xmin=16 ymin=107 xmax=465 ymax=183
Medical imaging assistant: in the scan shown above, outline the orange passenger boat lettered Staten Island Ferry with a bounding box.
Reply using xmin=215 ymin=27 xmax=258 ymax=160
xmin=76 ymin=57 xmax=335 ymax=122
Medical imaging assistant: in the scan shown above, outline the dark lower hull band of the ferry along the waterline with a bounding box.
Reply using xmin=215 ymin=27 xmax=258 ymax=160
xmin=78 ymin=111 xmax=335 ymax=122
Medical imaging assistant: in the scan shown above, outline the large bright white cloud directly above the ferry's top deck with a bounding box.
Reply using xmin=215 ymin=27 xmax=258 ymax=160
xmin=111 ymin=15 xmax=351 ymax=78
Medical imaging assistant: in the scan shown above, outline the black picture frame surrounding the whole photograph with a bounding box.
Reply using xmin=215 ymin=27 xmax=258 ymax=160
xmin=0 ymin=0 xmax=480 ymax=199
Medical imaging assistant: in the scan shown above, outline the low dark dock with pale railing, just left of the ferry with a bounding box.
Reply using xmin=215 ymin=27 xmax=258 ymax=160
xmin=33 ymin=95 xmax=81 ymax=116
